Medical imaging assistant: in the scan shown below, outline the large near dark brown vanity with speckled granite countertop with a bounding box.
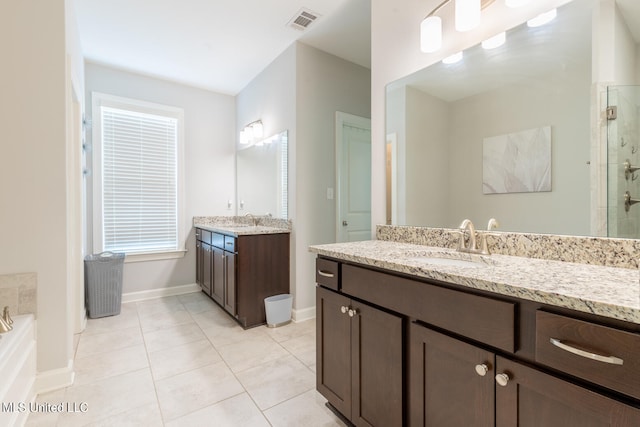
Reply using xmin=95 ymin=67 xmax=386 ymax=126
xmin=311 ymin=236 xmax=640 ymax=427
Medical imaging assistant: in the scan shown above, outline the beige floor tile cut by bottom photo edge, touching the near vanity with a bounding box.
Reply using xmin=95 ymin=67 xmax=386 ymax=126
xmin=264 ymin=390 xmax=345 ymax=427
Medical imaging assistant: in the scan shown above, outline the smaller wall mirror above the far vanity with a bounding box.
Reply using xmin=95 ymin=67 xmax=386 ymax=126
xmin=236 ymin=131 xmax=288 ymax=219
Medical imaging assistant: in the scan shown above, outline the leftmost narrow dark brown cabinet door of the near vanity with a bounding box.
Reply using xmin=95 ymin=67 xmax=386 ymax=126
xmin=316 ymin=287 xmax=351 ymax=418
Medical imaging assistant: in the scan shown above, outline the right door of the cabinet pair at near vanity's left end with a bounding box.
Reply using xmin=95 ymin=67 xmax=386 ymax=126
xmin=349 ymin=301 xmax=402 ymax=426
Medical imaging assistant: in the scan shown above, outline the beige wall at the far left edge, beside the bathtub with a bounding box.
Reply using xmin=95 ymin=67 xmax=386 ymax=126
xmin=0 ymin=0 xmax=82 ymax=387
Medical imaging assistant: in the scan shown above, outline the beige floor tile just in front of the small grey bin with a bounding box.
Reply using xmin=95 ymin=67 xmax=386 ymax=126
xmin=217 ymin=336 xmax=289 ymax=373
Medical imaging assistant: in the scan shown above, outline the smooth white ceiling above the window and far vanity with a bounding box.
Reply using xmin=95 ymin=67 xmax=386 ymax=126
xmin=74 ymin=0 xmax=371 ymax=95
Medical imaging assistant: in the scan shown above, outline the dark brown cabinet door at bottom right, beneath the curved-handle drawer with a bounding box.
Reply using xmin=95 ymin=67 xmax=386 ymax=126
xmin=496 ymin=357 xmax=640 ymax=427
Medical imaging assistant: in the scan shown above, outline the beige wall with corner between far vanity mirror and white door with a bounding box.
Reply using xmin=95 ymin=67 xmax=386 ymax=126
xmin=237 ymin=43 xmax=370 ymax=318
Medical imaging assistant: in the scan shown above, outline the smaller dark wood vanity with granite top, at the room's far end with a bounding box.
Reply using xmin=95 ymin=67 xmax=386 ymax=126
xmin=194 ymin=219 xmax=290 ymax=328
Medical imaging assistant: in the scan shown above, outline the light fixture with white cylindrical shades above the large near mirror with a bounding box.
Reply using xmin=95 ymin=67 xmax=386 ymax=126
xmin=420 ymin=0 xmax=495 ymax=53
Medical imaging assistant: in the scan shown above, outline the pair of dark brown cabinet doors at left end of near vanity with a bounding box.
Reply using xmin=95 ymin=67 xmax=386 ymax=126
xmin=316 ymin=287 xmax=403 ymax=426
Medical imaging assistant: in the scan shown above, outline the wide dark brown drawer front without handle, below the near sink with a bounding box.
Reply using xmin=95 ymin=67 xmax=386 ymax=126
xmin=341 ymin=265 xmax=516 ymax=352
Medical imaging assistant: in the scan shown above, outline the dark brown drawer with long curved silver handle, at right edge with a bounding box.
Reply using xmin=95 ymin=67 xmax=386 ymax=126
xmin=536 ymin=311 xmax=640 ymax=399
